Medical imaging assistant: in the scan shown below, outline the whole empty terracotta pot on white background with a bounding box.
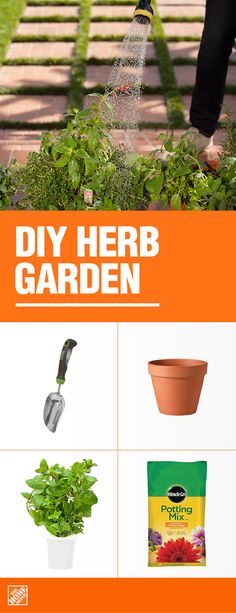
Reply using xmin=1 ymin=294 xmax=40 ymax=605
xmin=148 ymin=360 xmax=207 ymax=415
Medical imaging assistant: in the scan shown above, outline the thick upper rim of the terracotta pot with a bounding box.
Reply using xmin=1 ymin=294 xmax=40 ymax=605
xmin=148 ymin=358 xmax=208 ymax=378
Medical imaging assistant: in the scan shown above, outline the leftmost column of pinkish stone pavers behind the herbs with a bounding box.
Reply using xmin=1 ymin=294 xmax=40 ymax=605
xmin=0 ymin=2 xmax=80 ymax=135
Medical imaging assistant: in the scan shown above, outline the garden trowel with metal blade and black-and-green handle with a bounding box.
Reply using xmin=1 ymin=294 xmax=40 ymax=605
xmin=43 ymin=338 xmax=77 ymax=432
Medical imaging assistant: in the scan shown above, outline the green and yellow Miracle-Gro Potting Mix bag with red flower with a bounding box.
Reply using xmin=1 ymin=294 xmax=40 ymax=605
xmin=148 ymin=462 xmax=207 ymax=566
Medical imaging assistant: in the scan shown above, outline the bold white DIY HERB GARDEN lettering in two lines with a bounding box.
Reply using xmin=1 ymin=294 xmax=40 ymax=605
xmin=15 ymin=225 xmax=159 ymax=295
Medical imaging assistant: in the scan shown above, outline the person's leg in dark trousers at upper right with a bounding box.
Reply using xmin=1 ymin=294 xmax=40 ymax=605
xmin=190 ymin=0 xmax=236 ymax=137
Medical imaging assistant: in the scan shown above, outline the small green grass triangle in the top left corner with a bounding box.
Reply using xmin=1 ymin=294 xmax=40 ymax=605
xmin=0 ymin=0 xmax=26 ymax=64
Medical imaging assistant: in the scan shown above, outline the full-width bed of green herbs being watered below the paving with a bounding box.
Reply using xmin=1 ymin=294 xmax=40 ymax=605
xmin=0 ymin=94 xmax=236 ymax=210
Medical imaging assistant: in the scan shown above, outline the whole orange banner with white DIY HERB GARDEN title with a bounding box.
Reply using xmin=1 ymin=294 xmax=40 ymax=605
xmin=0 ymin=211 xmax=236 ymax=322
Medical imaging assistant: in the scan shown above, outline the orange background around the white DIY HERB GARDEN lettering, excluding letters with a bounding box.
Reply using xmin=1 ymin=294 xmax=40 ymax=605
xmin=0 ymin=211 xmax=236 ymax=321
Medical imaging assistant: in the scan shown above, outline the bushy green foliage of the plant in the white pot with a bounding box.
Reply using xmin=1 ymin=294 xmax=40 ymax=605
xmin=22 ymin=459 xmax=98 ymax=537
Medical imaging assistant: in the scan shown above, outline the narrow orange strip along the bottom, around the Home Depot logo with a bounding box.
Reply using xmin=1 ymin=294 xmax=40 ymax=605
xmin=0 ymin=580 xmax=236 ymax=613
